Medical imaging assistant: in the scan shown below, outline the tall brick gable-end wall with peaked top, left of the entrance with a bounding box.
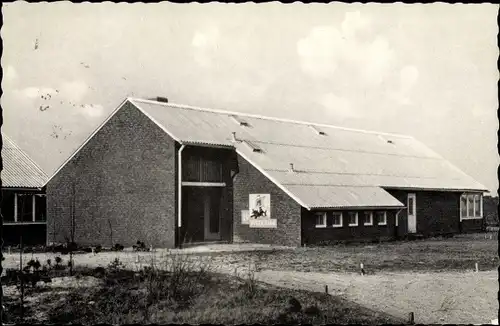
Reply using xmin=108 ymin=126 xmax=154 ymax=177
xmin=47 ymin=103 xmax=177 ymax=247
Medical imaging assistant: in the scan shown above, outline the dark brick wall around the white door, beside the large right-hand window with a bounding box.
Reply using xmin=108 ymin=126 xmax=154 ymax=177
xmin=388 ymin=190 xmax=460 ymax=236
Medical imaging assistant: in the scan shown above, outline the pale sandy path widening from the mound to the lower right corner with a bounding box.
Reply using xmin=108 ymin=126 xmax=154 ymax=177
xmin=252 ymin=270 xmax=498 ymax=324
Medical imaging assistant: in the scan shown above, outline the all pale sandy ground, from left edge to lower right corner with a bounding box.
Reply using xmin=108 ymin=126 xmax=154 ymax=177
xmin=3 ymin=245 xmax=499 ymax=324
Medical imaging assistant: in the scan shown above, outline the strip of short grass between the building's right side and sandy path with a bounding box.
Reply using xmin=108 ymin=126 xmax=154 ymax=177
xmin=196 ymin=235 xmax=499 ymax=273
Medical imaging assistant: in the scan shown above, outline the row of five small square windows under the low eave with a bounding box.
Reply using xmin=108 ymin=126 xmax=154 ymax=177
xmin=315 ymin=211 xmax=387 ymax=228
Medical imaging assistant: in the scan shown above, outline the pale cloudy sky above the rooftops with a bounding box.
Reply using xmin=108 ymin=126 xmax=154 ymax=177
xmin=1 ymin=1 xmax=500 ymax=194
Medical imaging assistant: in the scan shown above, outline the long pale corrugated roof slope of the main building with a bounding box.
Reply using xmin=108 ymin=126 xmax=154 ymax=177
xmin=129 ymin=99 xmax=486 ymax=207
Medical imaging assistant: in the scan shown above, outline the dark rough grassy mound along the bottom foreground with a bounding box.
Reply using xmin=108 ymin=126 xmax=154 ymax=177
xmin=2 ymin=258 xmax=401 ymax=324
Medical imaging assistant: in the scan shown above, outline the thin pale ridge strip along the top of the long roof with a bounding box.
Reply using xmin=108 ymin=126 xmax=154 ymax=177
xmin=127 ymin=97 xmax=413 ymax=139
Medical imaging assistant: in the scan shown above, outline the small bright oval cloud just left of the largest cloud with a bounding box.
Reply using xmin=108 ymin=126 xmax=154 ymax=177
xmin=191 ymin=26 xmax=220 ymax=67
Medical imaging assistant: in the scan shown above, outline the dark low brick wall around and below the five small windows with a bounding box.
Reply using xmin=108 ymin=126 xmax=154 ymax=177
xmin=302 ymin=209 xmax=397 ymax=244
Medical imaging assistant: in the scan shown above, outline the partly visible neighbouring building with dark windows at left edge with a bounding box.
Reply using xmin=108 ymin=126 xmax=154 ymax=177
xmin=1 ymin=133 xmax=48 ymax=246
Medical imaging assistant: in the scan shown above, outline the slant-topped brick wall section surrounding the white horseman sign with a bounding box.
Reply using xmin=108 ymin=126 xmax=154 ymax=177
xmin=233 ymin=155 xmax=301 ymax=246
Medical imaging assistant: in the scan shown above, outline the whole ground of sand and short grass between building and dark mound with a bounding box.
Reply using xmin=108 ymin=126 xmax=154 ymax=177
xmin=3 ymin=235 xmax=499 ymax=324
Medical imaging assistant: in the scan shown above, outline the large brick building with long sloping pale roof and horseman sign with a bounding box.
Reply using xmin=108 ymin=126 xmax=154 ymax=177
xmin=47 ymin=98 xmax=485 ymax=247
